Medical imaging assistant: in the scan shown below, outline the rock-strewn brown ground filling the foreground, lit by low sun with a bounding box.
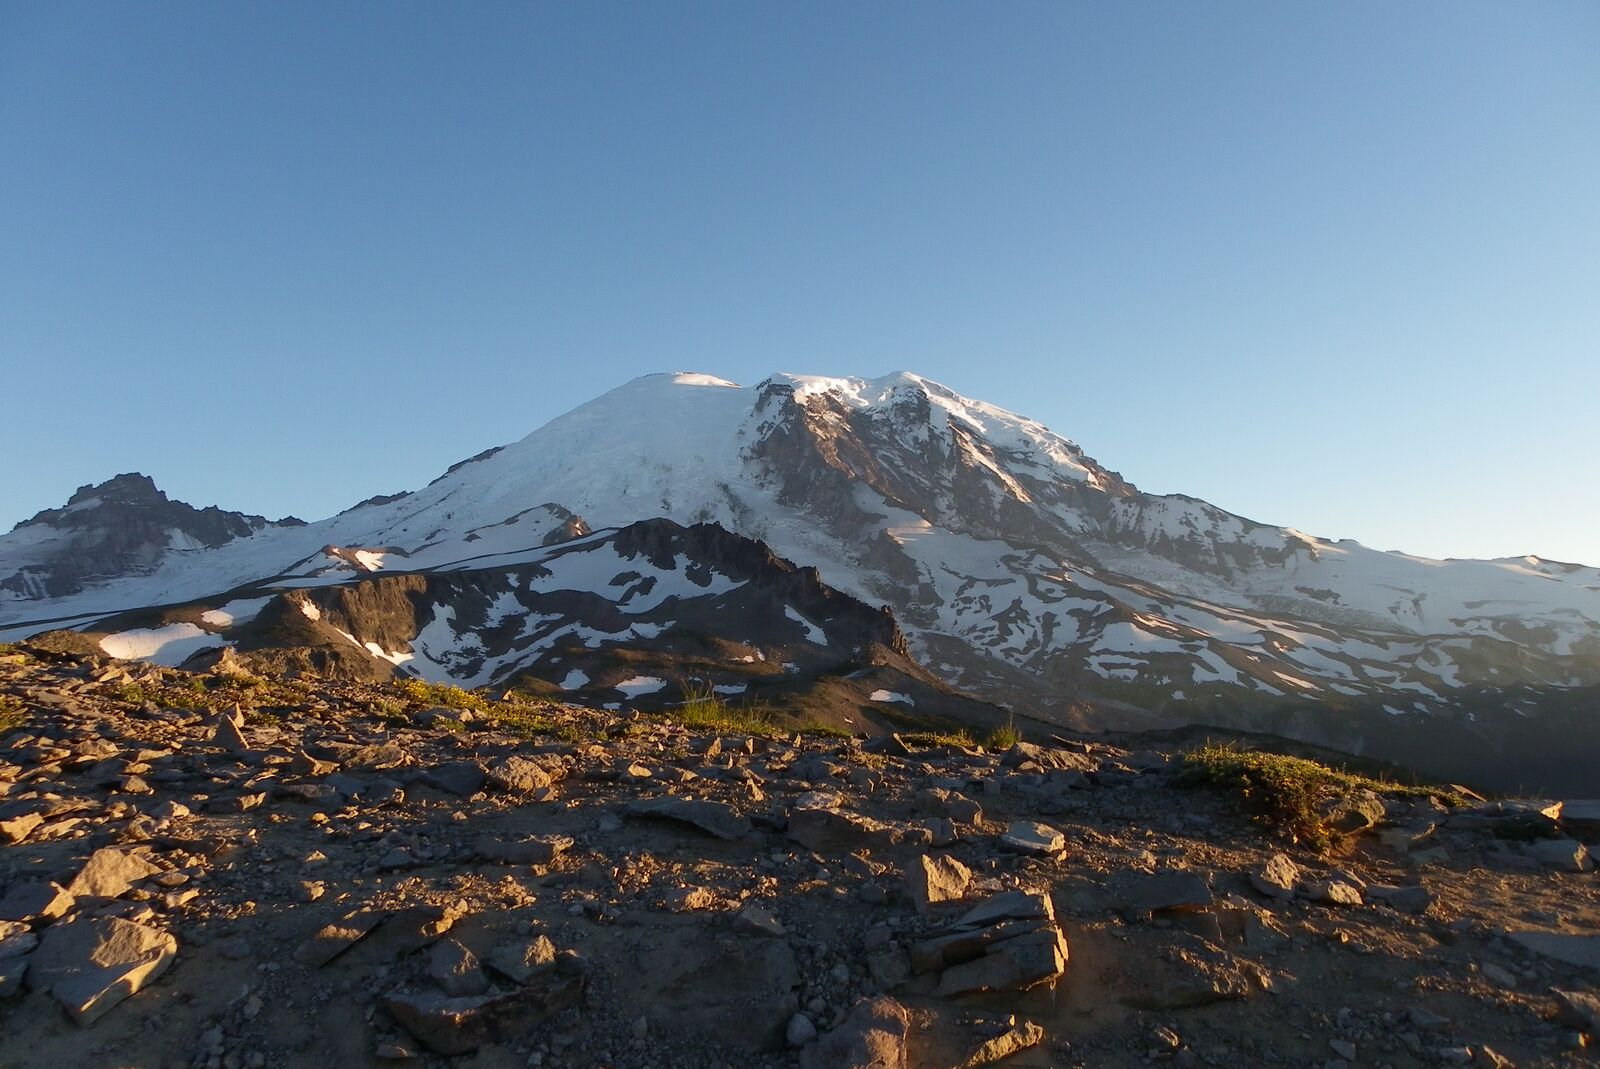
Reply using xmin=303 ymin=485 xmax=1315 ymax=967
xmin=0 ymin=651 xmax=1600 ymax=1069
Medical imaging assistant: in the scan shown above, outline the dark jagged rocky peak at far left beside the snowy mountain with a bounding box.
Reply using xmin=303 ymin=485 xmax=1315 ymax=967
xmin=0 ymin=472 xmax=304 ymax=600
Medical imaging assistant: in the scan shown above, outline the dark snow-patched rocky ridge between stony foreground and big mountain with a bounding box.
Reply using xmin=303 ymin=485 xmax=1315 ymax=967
xmin=43 ymin=512 xmax=1005 ymax=739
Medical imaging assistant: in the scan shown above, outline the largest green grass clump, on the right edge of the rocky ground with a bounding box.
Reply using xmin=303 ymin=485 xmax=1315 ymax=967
xmin=1178 ymin=743 xmax=1466 ymax=850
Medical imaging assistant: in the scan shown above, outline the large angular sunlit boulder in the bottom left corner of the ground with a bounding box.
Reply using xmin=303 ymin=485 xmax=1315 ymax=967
xmin=27 ymin=917 xmax=178 ymax=1024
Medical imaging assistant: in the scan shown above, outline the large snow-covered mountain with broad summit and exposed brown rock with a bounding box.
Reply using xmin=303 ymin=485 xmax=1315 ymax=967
xmin=0 ymin=373 xmax=1600 ymax=790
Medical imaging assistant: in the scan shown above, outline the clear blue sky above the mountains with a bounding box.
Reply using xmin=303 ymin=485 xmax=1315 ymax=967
xmin=0 ymin=0 xmax=1600 ymax=563
